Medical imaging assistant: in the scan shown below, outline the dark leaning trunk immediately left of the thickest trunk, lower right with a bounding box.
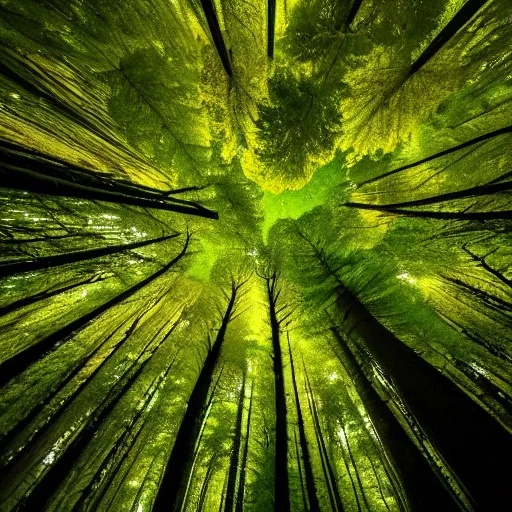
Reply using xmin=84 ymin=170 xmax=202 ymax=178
xmin=331 ymin=327 xmax=459 ymax=512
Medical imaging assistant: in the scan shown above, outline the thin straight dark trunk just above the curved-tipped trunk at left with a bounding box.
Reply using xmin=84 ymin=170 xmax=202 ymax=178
xmin=0 ymin=234 xmax=179 ymax=278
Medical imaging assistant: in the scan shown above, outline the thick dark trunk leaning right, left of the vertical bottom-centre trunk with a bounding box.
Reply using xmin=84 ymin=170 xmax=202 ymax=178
xmin=153 ymin=283 xmax=242 ymax=512
